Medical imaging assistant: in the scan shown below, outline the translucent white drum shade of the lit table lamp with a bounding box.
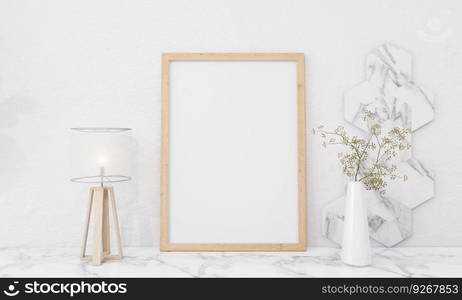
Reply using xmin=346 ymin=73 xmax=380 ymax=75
xmin=71 ymin=128 xmax=132 ymax=179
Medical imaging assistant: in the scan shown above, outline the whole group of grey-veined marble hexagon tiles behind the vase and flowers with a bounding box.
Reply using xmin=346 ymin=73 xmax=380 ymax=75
xmin=322 ymin=44 xmax=434 ymax=247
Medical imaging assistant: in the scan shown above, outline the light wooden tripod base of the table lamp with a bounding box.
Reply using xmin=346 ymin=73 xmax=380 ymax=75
xmin=80 ymin=186 xmax=123 ymax=265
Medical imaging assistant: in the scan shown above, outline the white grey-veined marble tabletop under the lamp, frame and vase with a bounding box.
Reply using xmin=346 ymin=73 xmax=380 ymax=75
xmin=0 ymin=248 xmax=462 ymax=277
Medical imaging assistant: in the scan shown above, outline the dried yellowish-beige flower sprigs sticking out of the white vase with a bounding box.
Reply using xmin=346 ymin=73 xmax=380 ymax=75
xmin=313 ymin=110 xmax=410 ymax=194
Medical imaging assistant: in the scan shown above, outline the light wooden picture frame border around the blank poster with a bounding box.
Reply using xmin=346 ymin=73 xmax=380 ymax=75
xmin=160 ymin=53 xmax=306 ymax=251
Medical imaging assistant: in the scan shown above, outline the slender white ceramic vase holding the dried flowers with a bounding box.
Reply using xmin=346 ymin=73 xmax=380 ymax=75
xmin=342 ymin=181 xmax=371 ymax=267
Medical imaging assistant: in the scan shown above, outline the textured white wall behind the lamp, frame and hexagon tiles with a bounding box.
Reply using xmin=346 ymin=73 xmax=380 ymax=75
xmin=0 ymin=0 xmax=462 ymax=247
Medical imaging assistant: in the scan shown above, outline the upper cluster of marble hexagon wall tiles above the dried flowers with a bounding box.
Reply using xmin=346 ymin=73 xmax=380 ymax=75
xmin=344 ymin=44 xmax=434 ymax=131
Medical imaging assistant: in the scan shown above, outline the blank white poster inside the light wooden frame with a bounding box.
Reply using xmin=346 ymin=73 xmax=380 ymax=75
xmin=168 ymin=61 xmax=298 ymax=243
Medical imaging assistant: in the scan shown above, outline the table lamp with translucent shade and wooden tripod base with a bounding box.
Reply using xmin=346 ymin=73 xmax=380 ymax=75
xmin=71 ymin=127 xmax=131 ymax=265
